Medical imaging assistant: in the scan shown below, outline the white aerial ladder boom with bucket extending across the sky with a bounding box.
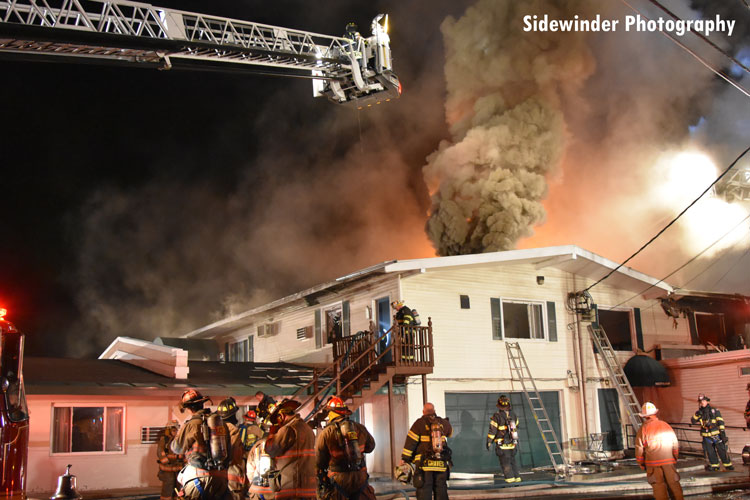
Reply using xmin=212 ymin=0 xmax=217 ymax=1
xmin=0 ymin=0 xmax=401 ymax=107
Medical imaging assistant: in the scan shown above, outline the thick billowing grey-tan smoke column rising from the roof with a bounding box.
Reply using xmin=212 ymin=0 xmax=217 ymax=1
xmin=424 ymin=0 xmax=593 ymax=255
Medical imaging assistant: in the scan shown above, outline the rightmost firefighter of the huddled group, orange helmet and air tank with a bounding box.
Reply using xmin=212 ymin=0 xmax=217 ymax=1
xmin=315 ymin=396 xmax=375 ymax=500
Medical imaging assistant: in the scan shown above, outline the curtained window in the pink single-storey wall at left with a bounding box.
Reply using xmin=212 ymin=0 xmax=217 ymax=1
xmin=52 ymin=406 xmax=125 ymax=453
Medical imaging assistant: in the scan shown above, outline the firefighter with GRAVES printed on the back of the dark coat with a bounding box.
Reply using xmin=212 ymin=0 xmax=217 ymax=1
xmin=401 ymin=403 xmax=453 ymax=500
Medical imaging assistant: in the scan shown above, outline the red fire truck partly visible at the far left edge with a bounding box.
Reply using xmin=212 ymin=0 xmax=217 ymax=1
xmin=0 ymin=309 xmax=29 ymax=500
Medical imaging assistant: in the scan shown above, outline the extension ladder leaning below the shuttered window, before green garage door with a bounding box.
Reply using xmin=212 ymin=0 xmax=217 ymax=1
xmin=505 ymin=342 xmax=568 ymax=474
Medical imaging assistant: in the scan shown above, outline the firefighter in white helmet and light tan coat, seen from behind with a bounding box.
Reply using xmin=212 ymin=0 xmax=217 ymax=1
xmin=635 ymin=402 xmax=683 ymax=500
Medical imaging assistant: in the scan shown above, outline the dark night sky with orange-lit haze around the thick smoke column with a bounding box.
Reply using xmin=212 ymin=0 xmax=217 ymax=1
xmin=0 ymin=0 xmax=750 ymax=357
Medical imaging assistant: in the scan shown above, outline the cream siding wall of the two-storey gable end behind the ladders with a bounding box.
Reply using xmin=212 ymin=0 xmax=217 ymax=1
xmin=402 ymin=264 xmax=690 ymax=458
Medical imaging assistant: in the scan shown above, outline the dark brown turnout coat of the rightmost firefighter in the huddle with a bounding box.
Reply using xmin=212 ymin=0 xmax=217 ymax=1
xmin=315 ymin=419 xmax=375 ymax=500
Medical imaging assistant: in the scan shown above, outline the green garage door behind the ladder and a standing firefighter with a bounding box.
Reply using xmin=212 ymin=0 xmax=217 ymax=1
xmin=445 ymin=391 xmax=561 ymax=472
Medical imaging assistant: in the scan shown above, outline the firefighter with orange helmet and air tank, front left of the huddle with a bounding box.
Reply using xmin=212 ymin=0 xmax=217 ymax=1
xmin=170 ymin=389 xmax=229 ymax=500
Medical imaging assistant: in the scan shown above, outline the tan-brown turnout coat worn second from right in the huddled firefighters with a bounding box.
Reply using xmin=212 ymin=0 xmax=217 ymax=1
xmin=266 ymin=415 xmax=317 ymax=499
